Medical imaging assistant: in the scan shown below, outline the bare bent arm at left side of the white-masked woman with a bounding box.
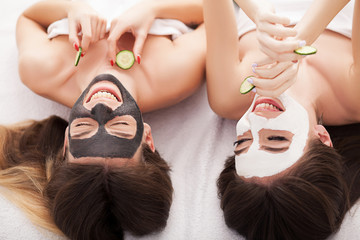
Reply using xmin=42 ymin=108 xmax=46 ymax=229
xmin=203 ymin=0 xmax=254 ymax=119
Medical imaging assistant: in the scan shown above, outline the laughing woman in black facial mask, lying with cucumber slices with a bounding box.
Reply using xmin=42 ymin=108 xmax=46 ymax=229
xmin=0 ymin=1 xmax=205 ymax=239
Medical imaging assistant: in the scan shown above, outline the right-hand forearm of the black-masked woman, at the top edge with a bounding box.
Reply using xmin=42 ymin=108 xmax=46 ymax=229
xmin=146 ymin=0 xmax=203 ymax=24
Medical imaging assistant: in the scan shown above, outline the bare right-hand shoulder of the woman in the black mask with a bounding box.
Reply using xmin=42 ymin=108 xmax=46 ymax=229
xmin=136 ymin=31 xmax=206 ymax=112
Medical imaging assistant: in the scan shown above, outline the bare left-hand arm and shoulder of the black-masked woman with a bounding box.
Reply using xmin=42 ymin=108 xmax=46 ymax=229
xmin=16 ymin=0 xmax=79 ymax=96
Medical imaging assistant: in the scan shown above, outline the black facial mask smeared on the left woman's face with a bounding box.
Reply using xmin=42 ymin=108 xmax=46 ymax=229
xmin=69 ymin=74 xmax=144 ymax=158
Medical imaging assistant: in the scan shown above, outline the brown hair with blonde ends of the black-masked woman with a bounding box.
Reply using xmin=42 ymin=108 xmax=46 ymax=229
xmin=0 ymin=116 xmax=173 ymax=239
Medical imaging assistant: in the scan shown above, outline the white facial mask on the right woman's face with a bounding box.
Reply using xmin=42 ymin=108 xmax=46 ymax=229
xmin=235 ymin=93 xmax=309 ymax=178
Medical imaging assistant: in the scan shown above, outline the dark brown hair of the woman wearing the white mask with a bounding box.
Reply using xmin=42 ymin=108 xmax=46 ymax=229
xmin=218 ymin=139 xmax=359 ymax=240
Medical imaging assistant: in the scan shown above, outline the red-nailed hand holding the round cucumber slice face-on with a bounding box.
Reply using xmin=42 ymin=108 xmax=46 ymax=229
xmin=108 ymin=2 xmax=156 ymax=64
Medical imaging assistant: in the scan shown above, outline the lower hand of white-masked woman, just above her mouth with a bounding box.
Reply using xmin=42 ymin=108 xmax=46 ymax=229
xmin=250 ymin=58 xmax=298 ymax=97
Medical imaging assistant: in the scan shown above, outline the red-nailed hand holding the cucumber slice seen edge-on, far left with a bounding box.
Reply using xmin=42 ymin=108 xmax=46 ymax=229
xmin=68 ymin=2 xmax=106 ymax=53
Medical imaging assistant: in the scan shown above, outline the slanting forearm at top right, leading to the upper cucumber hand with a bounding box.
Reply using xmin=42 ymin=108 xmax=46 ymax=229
xmin=295 ymin=0 xmax=350 ymax=45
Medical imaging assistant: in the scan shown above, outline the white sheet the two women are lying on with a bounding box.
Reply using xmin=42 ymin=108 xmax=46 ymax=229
xmin=0 ymin=0 xmax=360 ymax=240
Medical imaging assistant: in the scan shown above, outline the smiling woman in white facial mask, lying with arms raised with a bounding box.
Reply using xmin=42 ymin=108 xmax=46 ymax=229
xmin=204 ymin=0 xmax=360 ymax=240
